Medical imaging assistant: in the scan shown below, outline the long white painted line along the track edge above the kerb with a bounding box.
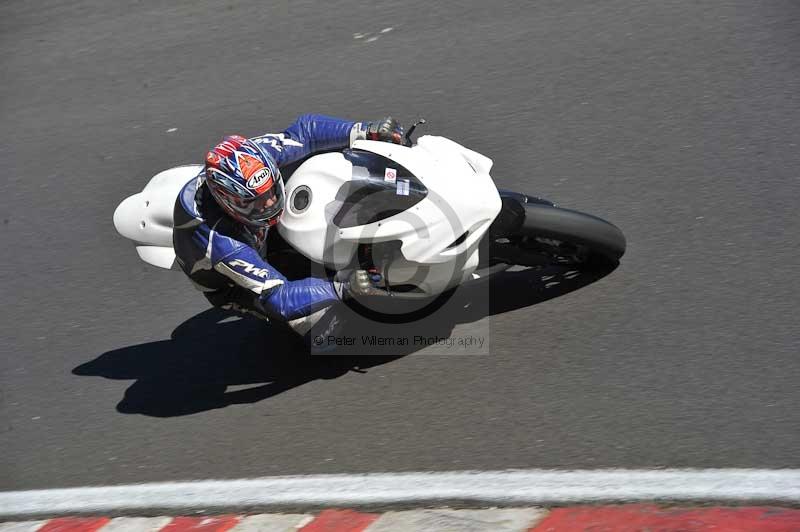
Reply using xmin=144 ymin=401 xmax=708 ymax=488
xmin=0 ymin=469 xmax=800 ymax=516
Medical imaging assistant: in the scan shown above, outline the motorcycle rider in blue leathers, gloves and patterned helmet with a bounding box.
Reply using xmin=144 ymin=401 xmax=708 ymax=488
xmin=173 ymin=115 xmax=402 ymax=334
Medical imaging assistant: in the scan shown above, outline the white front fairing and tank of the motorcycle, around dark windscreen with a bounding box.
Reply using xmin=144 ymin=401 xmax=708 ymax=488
xmin=278 ymin=136 xmax=501 ymax=293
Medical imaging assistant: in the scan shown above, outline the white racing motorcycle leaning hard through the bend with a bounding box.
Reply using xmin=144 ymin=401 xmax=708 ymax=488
xmin=114 ymin=124 xmax=625 ymax=314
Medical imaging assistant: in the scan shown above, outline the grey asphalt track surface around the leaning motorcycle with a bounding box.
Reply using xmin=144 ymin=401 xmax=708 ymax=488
xmin=0 ymin=0 xmax=800 ymax=490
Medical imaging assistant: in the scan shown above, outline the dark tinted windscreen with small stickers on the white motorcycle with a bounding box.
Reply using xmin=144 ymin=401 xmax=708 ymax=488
xmin=333 ymin=150 xmax=428 ymax=228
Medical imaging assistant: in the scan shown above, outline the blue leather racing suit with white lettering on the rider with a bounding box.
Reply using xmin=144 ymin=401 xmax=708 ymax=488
xmin=173 ymin=115 xmax=355 ymax=322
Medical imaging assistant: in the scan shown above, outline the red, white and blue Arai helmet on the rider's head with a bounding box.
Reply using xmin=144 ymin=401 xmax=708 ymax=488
xmin=205 ymin=135 xmax=285 ymax=227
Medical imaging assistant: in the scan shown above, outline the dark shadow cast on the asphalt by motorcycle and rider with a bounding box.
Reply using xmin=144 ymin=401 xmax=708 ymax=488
xmin=72 ymin=260 xmax=614 ymax=417
